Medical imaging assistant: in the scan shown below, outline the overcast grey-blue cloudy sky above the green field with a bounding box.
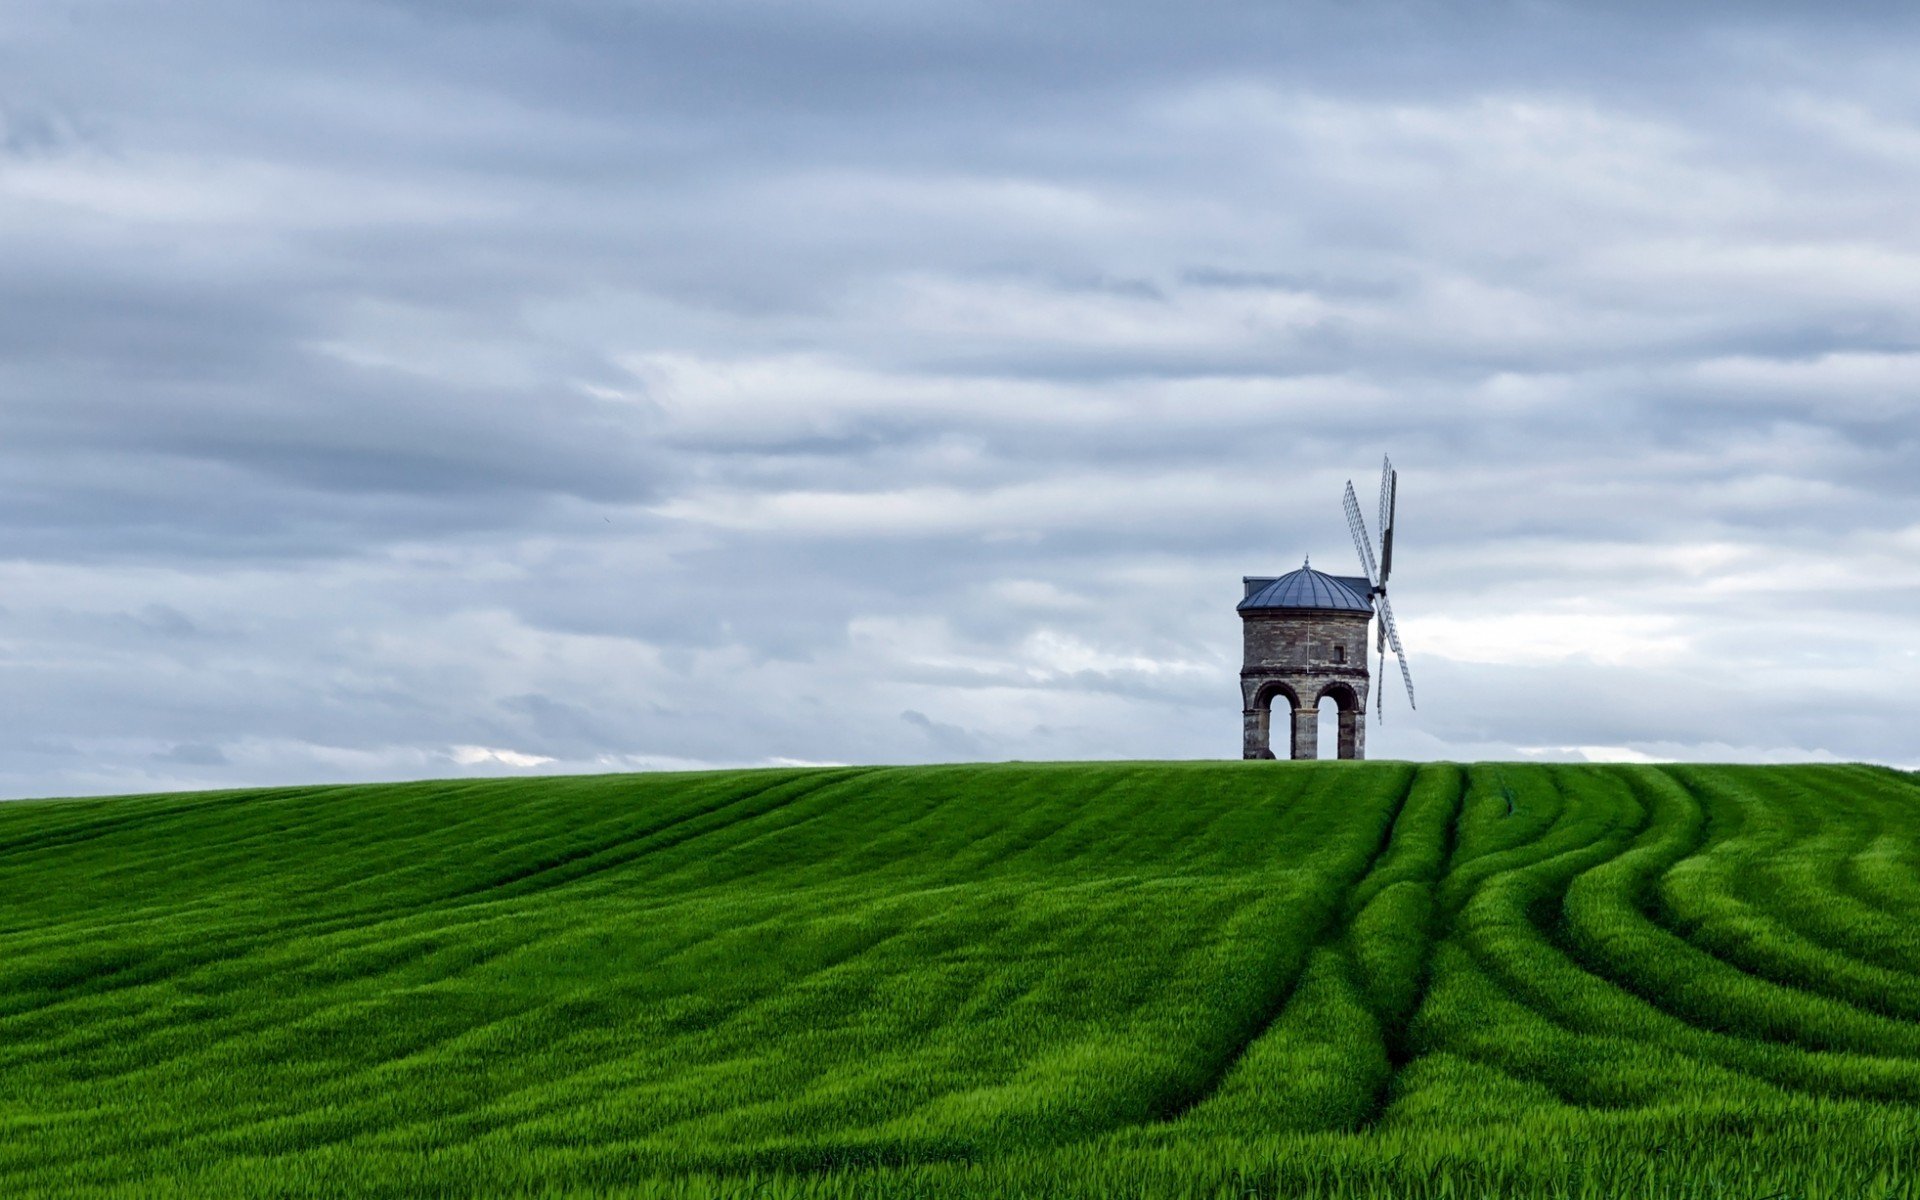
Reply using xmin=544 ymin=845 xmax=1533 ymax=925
xmin=0 ymin=0 xmax=1920 ymax=797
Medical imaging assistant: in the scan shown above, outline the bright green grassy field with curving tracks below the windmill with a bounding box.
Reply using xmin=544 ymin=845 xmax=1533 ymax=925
xmin=0 ymin=762 xmax=1920 ymax=1200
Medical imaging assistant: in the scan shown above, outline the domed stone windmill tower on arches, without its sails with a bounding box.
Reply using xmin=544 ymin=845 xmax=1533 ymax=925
xmin=1240 ymin=566 xmax=1373 ymax=758
